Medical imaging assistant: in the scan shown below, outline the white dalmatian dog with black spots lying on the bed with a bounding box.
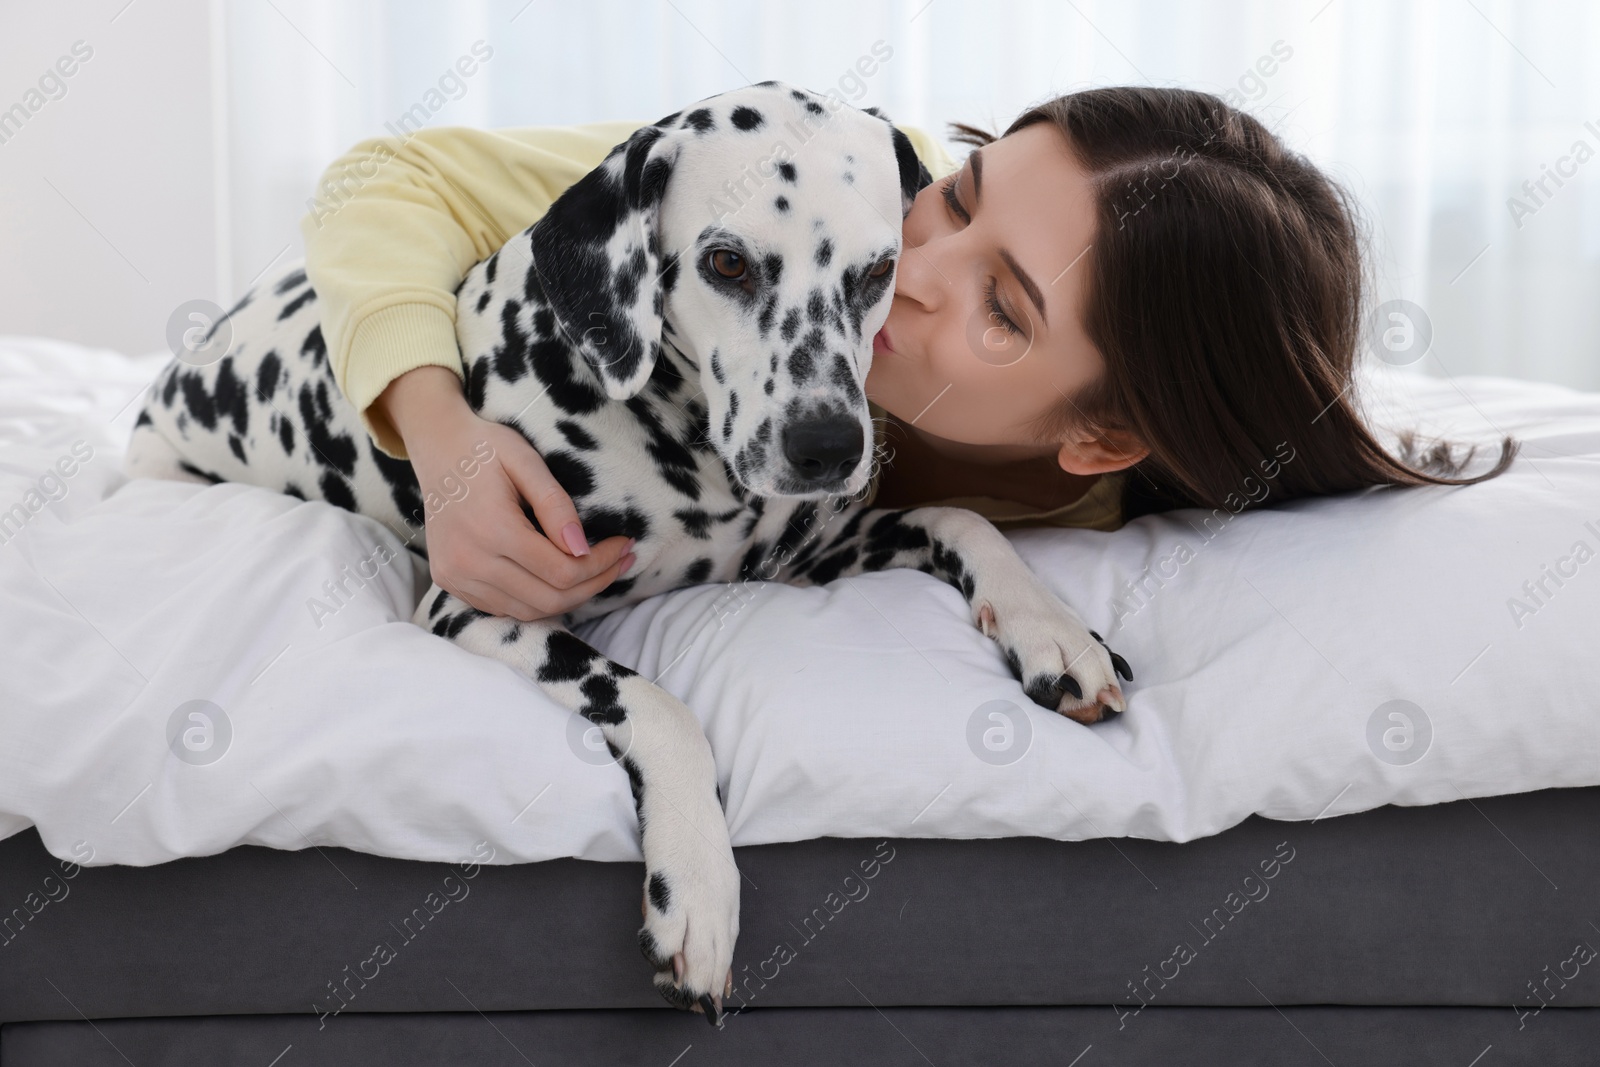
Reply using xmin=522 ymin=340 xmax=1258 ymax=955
xmin=125 ymin=82 xmax=1131 ymax=1024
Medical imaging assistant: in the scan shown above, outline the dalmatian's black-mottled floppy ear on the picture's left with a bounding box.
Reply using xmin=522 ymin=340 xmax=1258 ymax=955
xmin=531 ymin=126 xmax=683 ymax=400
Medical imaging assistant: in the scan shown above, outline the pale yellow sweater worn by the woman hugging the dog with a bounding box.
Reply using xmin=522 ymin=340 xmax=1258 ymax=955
xmin=301 ymin=122 xmax=1122 ymax=530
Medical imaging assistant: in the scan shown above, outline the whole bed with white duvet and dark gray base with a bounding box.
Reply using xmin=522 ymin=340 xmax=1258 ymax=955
xmin=0 ymin=338 xmax=1600 ymax=1067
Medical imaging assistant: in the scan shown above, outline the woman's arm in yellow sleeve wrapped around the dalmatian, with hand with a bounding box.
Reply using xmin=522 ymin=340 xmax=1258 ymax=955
xmin=301 ymin=123 xmax=640 ymax=621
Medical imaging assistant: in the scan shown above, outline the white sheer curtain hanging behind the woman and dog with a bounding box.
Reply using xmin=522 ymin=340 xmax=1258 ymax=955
xmin=222 ymin=0 xmax=1600 ymax=389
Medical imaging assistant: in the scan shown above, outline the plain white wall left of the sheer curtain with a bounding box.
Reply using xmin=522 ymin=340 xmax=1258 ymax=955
xmin=0 ymin=0 xmax=227 ymax=352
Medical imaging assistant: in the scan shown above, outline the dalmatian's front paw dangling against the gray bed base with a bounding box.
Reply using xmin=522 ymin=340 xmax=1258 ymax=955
xmin=638 ymin=801 xmax=739 ymax=1027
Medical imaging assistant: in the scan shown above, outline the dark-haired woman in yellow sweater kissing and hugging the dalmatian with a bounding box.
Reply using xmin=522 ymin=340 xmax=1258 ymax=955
xmin=302 ymin=88 xmax=1517 ymax=619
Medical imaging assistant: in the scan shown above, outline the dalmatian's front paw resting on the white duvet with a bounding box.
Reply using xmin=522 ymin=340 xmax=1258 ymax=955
xmin=978 ymin=593 xmax=1133 ymax=723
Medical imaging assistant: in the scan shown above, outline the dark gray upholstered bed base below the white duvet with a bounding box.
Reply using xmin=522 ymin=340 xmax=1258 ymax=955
xmin=0 ymin=789 xmax=1600 ymax=1067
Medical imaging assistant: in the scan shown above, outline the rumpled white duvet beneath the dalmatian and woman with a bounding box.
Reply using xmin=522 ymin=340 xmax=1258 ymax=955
xmin=0 ymin=338 xmax=1600 ymax=865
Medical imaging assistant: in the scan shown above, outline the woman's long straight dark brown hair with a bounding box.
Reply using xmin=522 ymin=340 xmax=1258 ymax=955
xmin=949 ymin=86 xmax=1518 ymax=520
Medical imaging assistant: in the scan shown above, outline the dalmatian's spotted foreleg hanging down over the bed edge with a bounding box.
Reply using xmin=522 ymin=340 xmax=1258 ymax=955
xmin=413 ymin=585 xmax=739 ymax=1022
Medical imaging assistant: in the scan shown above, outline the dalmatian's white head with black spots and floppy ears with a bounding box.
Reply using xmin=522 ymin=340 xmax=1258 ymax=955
xmin=531 ymin=82 xmax=930 ymax=498
